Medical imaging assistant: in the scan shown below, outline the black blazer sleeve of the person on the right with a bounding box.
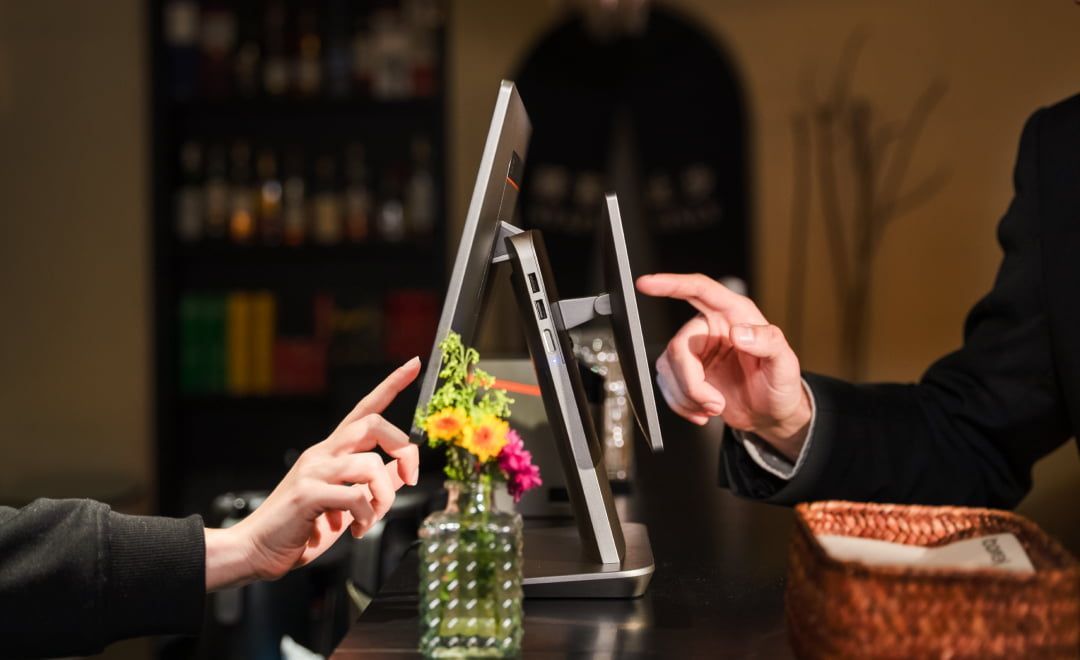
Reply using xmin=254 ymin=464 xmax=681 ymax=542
xmin=720 ymin=106 xmax=1080 ymax=508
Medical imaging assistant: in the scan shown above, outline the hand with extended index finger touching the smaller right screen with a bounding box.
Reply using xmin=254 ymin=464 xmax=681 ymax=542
xmin=637 ymin=273 xmax=810 ymax=460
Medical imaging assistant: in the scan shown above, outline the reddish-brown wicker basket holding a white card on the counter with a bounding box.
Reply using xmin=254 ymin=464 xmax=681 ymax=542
xmin=785 ymin=501 xmax=1080 ymax=658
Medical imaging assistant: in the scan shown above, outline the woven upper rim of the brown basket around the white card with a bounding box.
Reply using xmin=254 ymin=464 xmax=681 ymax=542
xmin=795 ymin=500 xmax=1080 ymax=584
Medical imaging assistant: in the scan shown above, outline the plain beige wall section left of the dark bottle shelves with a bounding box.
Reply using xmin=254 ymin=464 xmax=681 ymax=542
xmin=0 ymin=0 xmax=151 ymax=505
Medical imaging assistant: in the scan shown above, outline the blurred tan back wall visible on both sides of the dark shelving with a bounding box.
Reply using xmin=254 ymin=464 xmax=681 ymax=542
xmin=0 ymin=0 xmax=1080 ymax=533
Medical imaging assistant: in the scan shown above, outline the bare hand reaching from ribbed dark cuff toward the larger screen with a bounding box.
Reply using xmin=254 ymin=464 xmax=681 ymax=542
xmin=206 ymin=358 xmax=420 ymax=591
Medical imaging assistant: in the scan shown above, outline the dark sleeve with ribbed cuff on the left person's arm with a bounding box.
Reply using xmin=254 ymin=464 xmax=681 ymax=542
xmin=0 ymin=499 xmax=206 ymax=658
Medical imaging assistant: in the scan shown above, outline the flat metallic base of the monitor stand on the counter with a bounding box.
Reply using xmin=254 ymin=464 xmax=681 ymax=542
xmin=524 ymin=523 xmax=656 ymax=598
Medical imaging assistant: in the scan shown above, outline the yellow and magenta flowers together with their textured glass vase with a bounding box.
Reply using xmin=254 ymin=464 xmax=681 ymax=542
xmin=416 ymin=332 xmax=541 ymax=657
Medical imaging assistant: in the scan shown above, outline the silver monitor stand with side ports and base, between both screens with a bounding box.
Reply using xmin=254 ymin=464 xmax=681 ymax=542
xmin=492 ymin=225 xmax=654 ymax=598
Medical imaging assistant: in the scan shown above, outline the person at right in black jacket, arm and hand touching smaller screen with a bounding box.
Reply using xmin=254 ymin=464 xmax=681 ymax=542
xmin=637 ymin=95 xmax=1080 ymax=508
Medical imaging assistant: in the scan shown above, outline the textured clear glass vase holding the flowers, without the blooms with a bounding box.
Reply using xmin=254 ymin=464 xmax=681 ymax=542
xmin=420 ymin=482 xmax=522 ymax=658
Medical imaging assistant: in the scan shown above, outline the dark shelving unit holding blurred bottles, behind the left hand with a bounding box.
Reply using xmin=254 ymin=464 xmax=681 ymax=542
xmin=148 ymin=0 xmax=446 ymax=515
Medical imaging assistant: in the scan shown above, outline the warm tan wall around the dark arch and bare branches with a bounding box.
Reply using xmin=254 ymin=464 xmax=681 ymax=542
xmin=448 ymin=0 xmax=1080 ymax=526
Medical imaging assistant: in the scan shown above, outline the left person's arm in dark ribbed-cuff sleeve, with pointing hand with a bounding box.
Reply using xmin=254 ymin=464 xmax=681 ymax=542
xmin=0 ymin=358 xmax=420 ymax=658
